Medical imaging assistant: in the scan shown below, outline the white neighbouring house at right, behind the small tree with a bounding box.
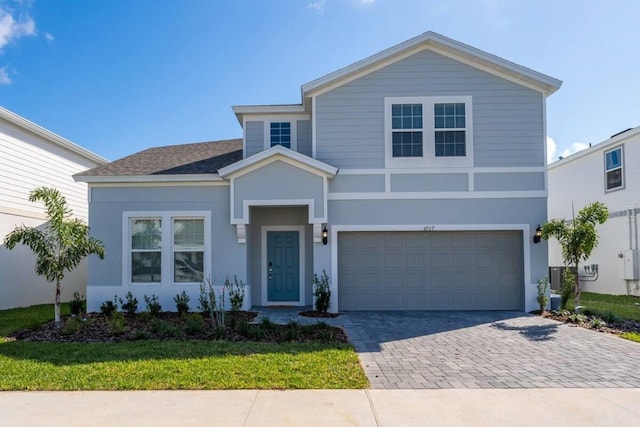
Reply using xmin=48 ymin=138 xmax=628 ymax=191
xmin=548 ymin=127 xmax=640 ymax=295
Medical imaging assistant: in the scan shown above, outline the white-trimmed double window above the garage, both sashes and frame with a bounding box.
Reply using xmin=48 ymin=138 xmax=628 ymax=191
xmin=385 ymin=96 xmax=473 ymax=168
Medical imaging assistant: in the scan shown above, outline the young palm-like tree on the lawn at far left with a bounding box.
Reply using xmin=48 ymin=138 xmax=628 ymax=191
xmin=4 ymin=187 xmax=104 ymax=323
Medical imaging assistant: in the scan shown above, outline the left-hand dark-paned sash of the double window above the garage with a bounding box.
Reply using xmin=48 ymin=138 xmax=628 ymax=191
xmin=391 ymin=104 xmax=422 ymax=157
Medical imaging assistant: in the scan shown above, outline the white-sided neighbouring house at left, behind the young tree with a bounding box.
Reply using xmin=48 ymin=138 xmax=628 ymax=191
xmin=0 ymin=107 xmax=107 ymax=310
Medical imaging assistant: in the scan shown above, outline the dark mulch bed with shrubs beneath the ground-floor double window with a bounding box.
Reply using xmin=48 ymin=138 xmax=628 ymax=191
xmin=9 ymin=311 xmax=349 ymax=343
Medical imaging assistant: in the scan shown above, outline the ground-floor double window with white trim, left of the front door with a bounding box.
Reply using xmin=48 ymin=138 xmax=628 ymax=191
xmin=123 ymin=211 xmax=211 ymax=285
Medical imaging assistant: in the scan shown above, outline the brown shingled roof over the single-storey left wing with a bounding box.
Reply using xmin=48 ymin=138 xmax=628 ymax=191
xmin=74 ymin=138 xmax=242 ymax=182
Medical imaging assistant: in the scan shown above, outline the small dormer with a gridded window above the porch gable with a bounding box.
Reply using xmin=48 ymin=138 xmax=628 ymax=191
xmin=233 ymin=104 xmax=312 ymax=158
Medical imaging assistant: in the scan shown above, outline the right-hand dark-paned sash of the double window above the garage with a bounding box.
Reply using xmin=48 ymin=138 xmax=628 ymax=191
xmin=433 ymin=102 xmax=466 ymax=157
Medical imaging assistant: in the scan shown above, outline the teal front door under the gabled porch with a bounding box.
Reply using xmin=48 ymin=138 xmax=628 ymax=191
xmin=267 ymin=231 xmax=300 ymax=302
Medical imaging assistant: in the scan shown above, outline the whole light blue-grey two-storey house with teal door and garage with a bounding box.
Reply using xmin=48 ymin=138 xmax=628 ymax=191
xmin=76 ymin=32 xmax=561 ymax=311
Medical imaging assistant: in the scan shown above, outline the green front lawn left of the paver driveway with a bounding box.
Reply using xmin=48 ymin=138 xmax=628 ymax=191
xmin=0 ymin=305 xmax=368 ymax=390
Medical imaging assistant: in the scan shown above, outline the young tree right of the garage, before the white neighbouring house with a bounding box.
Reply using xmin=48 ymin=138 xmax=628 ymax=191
xmin=542 ymin=202 xmax=609 ymax=308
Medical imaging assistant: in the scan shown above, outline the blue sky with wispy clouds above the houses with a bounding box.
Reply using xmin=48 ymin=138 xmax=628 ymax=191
xmin=0 ymin=0 xmax=640 ymax=160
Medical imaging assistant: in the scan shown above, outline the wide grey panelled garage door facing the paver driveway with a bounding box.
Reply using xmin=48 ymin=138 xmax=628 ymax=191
xmin=338 ymin=231 xmax=524 ymax=310
